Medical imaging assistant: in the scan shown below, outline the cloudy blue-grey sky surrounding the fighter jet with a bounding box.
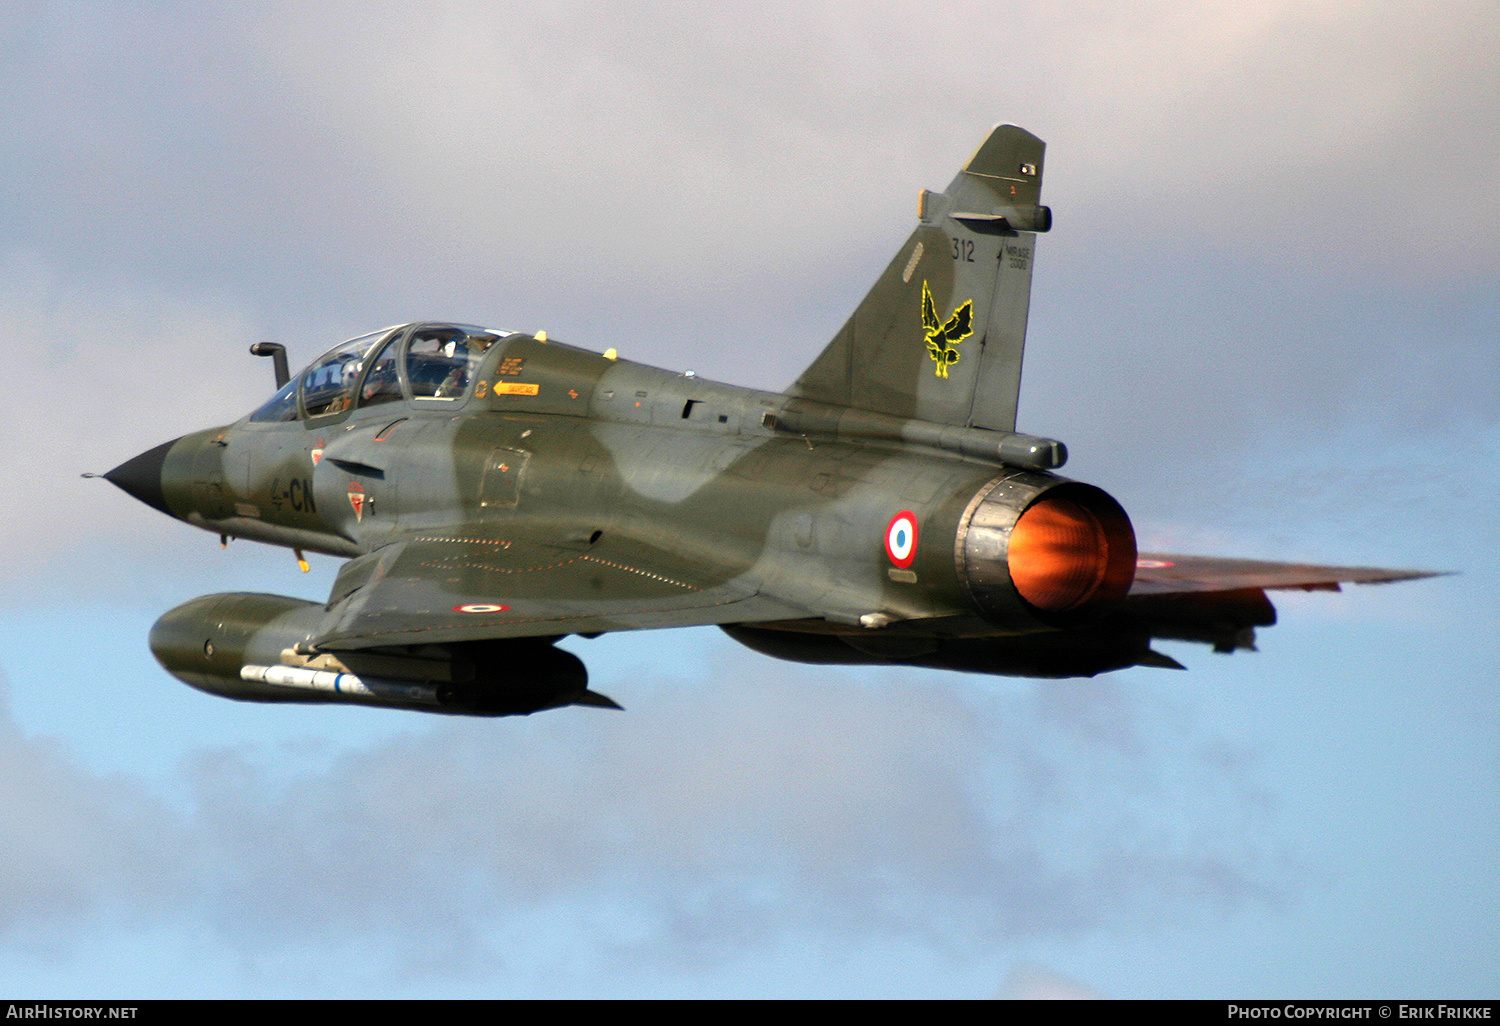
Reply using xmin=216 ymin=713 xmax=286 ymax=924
xmin=0 ymin=0 xmax=1500 ymax=998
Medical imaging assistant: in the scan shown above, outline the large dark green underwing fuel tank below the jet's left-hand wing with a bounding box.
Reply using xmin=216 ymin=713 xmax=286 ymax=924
xmin=152 ymin=593 xmax=620 ymax=716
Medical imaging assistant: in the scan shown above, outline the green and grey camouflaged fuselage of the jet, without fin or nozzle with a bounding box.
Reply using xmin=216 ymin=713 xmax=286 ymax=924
xmin=162 ymin=335 xmax=1080 ymax=638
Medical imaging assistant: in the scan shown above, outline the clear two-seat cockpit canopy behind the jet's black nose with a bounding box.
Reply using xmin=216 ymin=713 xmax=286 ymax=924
xmin=251 ymin=324 xmax=510 ymax=423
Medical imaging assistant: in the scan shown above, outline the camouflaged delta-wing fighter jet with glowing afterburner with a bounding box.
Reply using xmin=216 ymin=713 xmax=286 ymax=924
xmin=105 ymin=125 xmax=1428 ymax=716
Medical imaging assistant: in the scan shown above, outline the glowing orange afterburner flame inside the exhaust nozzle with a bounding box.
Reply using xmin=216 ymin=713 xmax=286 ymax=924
xmin=1008 ymin=498 xmax=1115 ymax=612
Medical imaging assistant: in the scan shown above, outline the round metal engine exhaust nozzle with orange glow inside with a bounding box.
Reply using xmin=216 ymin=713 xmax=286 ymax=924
xmin=954 ymin=471 xmax=1136 ymax=627
